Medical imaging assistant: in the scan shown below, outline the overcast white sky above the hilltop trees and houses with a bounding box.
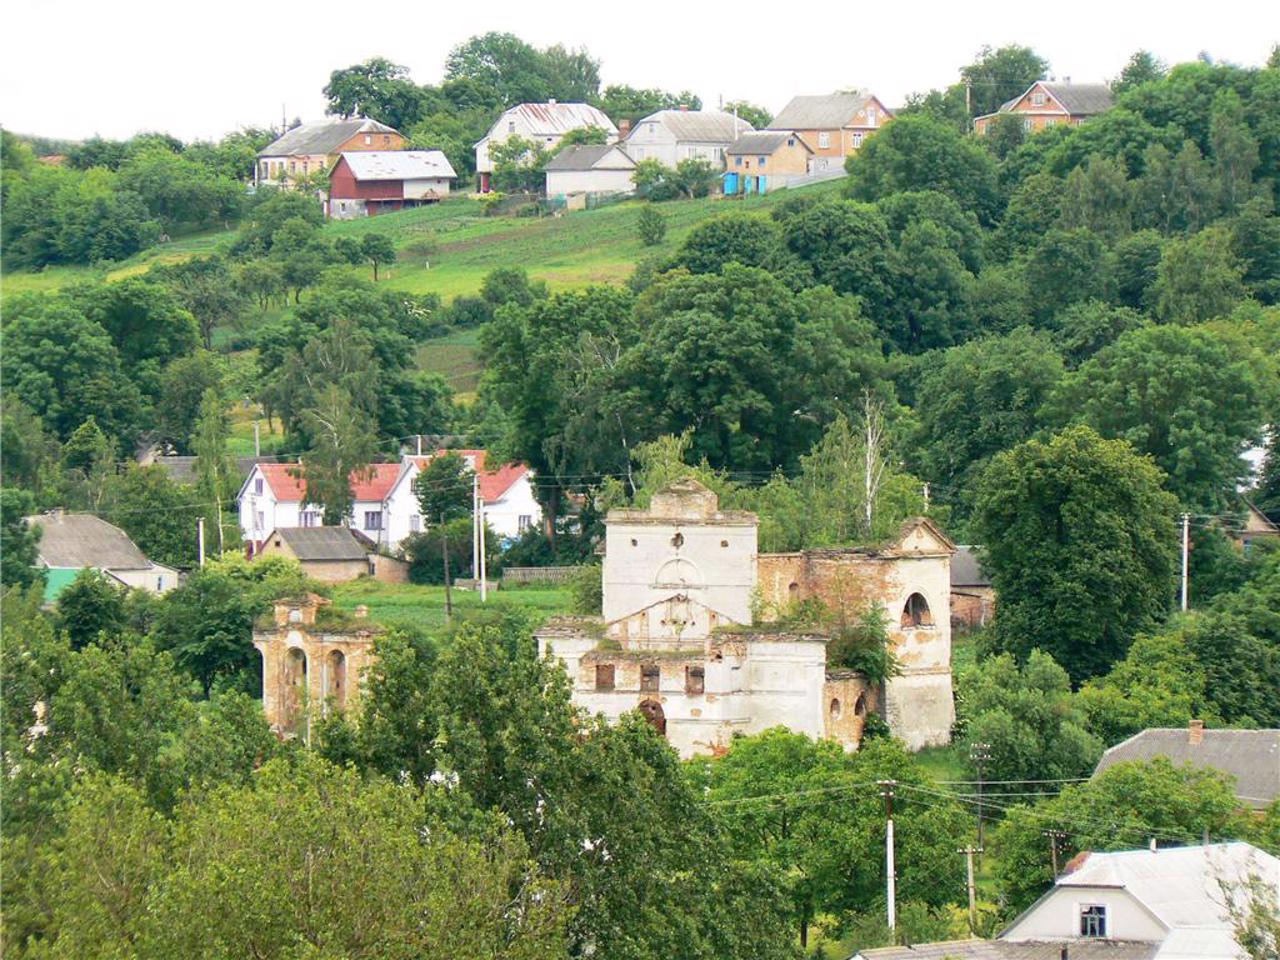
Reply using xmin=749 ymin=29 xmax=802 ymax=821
xmin=0 ymin=0 xmax=1280 ymax=140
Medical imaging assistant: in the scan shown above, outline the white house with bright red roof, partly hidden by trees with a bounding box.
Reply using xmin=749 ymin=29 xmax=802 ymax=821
xmin=238 ymin=449 xmax=543 ymax=553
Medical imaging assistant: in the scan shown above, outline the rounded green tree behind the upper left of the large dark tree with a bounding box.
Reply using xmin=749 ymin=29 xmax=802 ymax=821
xmin=913 ymin=326 xmax=1062 ymax=517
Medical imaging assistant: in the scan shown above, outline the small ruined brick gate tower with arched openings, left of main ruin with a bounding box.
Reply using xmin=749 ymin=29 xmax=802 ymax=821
xmin=253 ymin=594 xmax=379 ymax=742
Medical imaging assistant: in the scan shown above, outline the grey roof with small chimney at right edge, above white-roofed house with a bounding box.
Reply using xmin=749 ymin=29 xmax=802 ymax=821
xmin=1093 ymin=727 xmax=1280 ymax=809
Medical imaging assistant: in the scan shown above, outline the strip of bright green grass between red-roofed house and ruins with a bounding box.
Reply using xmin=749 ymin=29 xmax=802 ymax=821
xmin=333 ymin=577 xmax=572 ymax=630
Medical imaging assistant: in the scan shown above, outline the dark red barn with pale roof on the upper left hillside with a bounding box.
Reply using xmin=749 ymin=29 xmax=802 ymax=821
xmin=325 ymin=150 xmax=457 ymax=220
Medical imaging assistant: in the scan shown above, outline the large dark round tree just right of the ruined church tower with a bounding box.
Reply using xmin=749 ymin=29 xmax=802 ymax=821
xmin=973 ymin=428 xmax=1176 ymax=681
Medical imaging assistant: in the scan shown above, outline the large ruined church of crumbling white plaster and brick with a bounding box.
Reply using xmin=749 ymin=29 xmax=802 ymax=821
xmin=538 ymin=479 xmax=954 ymax=756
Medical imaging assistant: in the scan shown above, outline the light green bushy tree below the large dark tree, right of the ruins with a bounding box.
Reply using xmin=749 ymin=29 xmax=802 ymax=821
xmin=956 ymin=650 xmax=1103 ymax=786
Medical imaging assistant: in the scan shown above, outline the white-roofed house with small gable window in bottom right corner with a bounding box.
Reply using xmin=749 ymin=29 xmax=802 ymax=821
xmin=854 ymin=841 xmax=1280 ymax=960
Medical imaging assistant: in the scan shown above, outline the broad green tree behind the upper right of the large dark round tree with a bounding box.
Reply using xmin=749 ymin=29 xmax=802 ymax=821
xmin=1053 ymin=326 xmax=1263 ymax=508
